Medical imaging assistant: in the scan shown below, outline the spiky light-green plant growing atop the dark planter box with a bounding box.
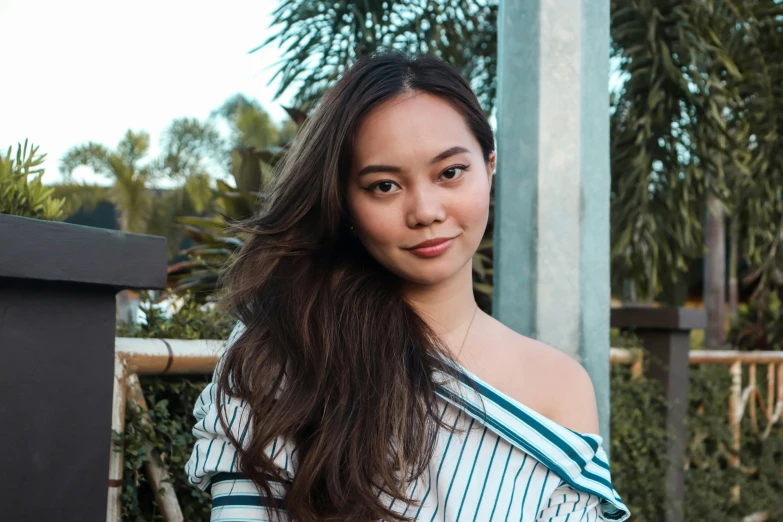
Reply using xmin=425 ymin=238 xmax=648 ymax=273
xmin=0 ymin=140 xmax=66 ymax=221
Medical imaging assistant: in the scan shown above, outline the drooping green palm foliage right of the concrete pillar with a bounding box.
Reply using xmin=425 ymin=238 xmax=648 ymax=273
xmin=611 ymin=0 xmax=783 ymax=298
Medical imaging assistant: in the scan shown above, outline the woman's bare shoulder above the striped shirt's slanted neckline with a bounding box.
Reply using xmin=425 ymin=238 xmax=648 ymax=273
xmin=472 ymin=319 xmax=598 ymax=433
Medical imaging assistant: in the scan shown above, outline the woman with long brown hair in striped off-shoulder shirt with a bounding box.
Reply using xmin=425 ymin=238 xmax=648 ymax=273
xmin=187 ymin=49 xmax=629 ymax=522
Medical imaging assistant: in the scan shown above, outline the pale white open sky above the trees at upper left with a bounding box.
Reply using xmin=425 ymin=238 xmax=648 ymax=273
xmin=0 ymin=0 xmax=293 ymax=183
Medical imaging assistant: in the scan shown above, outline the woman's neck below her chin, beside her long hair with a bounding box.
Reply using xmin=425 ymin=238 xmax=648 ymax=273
xmin=403 ymin=263 xmax=478 ymax=356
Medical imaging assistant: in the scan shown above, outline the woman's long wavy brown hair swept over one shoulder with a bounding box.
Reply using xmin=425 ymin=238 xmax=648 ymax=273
xmin=217 ymin=49 xmax=494 ymax=522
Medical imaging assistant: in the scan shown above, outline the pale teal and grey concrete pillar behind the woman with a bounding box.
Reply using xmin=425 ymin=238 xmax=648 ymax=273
xmin=493 ymin=0 xmax=610 ymax=442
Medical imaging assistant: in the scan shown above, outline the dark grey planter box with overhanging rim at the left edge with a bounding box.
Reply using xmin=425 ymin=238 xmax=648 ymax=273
xmin=0 ymin=215 xmax=166 ymax=522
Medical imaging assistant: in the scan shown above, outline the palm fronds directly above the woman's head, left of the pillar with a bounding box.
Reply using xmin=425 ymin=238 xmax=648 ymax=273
xmin=251 ymin=0 xmax=498 ymax=114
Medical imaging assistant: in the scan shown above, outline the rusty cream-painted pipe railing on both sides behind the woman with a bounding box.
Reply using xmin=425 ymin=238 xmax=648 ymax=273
xmin=107 ymin=338 xmax=783 ymax=522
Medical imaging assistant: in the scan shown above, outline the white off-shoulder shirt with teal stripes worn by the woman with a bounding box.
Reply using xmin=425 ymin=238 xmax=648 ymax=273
xmin=186 ymin=322 xmax=630 ymax=522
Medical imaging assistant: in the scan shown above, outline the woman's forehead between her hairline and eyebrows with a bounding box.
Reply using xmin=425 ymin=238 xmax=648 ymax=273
xmin=353 ymin=92 xmax=479 ymax=164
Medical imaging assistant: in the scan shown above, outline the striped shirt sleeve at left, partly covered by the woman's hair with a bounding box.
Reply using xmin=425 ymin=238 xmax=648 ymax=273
xmin=185 ymin=318 xmax=296 ymax=522
